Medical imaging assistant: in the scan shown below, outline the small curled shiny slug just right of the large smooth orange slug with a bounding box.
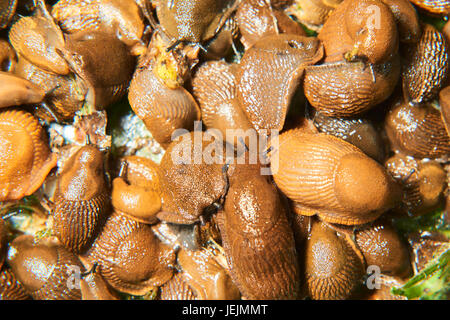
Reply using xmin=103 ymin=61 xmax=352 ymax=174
xmin=385 ymin=153 xmax=447 ymax=216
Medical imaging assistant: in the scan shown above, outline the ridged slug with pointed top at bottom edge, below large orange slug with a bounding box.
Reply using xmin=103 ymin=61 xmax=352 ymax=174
xmin=303 ymin=221 xmax=365 ymax=300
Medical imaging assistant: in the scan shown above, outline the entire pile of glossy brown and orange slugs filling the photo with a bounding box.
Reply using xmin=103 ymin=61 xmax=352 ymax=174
xmin=0 ymin=0 xmax=450 ymax=300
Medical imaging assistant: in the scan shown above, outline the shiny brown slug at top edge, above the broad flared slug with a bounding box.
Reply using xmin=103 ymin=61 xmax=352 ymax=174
xmin=236 ymin=0 xmax=306 ymax=49
